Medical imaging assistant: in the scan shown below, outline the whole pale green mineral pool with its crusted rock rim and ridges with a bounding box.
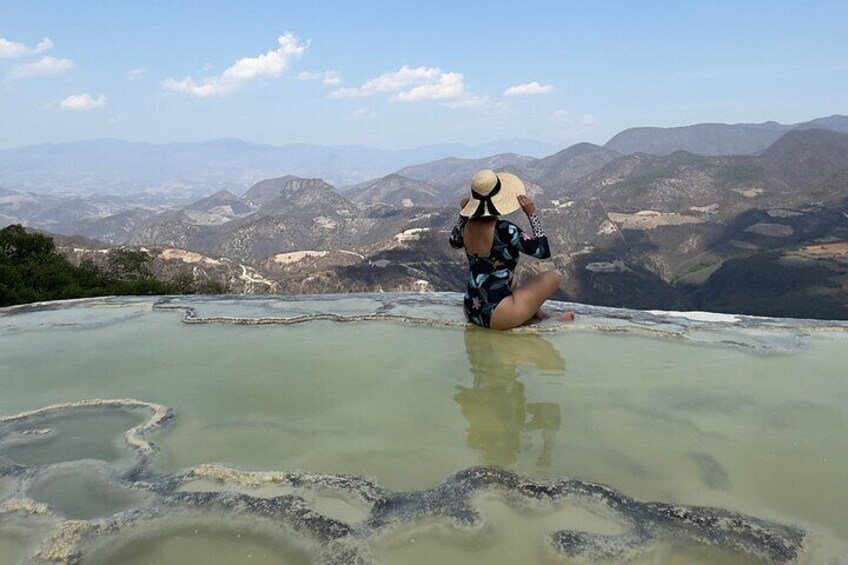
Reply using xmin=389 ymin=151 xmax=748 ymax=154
xmin=0 ymin=294 xmax=848 ymax=565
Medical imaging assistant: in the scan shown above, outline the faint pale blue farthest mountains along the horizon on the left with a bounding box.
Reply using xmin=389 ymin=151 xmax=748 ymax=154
xmin=0 ymin=139 xmax=555 ymax=200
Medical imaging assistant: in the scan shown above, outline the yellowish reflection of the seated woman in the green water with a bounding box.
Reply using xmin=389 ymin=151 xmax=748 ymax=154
xmin=454 ymin=328 xmax=565 ymax=467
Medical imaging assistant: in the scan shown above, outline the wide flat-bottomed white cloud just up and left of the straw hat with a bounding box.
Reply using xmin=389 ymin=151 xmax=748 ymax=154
xmin=329 ymin=65 xmax=484 ymax=108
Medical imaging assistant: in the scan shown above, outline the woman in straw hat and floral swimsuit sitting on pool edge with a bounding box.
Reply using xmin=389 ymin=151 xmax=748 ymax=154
xmin=450 ymin=169 xmax=574 ymax=330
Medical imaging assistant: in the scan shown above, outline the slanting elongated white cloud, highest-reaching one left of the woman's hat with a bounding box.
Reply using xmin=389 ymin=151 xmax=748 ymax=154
xmin=162 ymin=32 xmax=309 ymax=98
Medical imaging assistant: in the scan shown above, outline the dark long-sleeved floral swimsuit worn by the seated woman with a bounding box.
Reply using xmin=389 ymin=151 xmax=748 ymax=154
xmin=449 ymin=214 xmax=551 ymax=328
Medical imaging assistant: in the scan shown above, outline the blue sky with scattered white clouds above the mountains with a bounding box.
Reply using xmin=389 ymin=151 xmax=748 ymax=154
xmin=0 ymin=0 xmax=848 ymax=148
